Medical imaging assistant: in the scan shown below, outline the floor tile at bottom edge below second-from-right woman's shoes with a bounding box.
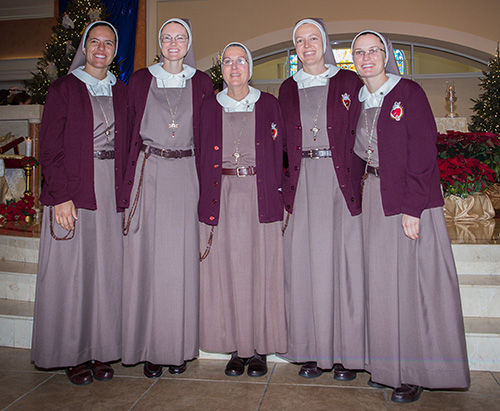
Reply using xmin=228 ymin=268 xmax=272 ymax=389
xmin=260 ymin=384 xmax=386 ymax=411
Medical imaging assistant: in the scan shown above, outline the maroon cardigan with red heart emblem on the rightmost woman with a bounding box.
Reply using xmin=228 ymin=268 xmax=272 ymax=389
xmin=353 ymin=79 xmax=443 ymax=218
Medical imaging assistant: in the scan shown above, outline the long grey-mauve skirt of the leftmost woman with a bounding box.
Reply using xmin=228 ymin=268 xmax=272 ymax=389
xmin=31 ymin=160 xmax=123 ymax=368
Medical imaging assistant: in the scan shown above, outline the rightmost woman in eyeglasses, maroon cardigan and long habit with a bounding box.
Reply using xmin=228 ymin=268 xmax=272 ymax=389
xmin=351 ymin=30 xmax=470 ymax=403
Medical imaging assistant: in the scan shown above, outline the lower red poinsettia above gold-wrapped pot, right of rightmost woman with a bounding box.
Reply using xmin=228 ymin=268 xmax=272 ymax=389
xmin=438 ymin=155 xmax=495 ymax=198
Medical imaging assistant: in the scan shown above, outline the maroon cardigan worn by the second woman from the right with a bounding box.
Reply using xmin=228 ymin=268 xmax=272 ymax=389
xmin=279 ymin=70 xmax=362 ymax=215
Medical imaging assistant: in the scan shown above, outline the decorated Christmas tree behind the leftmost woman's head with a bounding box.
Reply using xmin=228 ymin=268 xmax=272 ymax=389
xmin=25 ymin=0 xmax=119 ymax=104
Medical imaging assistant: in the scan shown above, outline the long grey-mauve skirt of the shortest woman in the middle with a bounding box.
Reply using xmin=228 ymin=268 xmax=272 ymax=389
xmin=200 ymin=176 xmax=287 ymax=357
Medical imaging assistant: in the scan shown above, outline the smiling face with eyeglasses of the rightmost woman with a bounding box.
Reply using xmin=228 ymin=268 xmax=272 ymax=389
xmin=352 ymin=34 xmax=386 ymax=80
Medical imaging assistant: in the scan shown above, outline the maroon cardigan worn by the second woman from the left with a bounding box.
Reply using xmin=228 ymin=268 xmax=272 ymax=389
xmin=119 ymin=68 xmax=213 ymax=208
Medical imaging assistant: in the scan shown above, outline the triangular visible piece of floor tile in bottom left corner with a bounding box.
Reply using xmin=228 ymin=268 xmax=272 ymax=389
xmin=0 ymin=371 xmax=53 ymax=409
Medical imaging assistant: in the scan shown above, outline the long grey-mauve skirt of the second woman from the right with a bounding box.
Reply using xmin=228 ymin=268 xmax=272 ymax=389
xmin=284 ymin=158 xmax=365 ymax=369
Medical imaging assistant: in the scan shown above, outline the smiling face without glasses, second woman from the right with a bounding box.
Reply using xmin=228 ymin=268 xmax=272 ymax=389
xmin=295 ymin=23 xmax=326 ymax=74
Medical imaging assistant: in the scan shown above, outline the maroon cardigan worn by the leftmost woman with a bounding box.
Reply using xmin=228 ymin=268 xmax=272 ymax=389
xmin=40 ymin=74 xmax=127 ymax=211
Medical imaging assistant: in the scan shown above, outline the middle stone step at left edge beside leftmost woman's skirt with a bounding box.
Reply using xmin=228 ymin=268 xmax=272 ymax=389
xmin=0 ymin=261 xmax=38 ymax=302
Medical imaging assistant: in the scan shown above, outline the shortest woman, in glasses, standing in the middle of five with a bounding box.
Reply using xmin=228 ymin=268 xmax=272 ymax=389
xmin=199 ymin=43 xmax=286 ymax=377
